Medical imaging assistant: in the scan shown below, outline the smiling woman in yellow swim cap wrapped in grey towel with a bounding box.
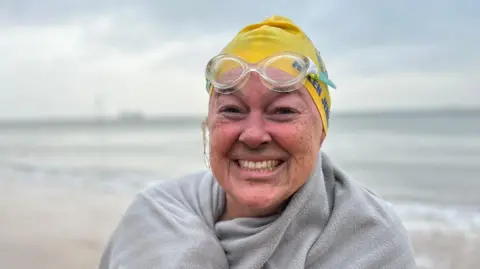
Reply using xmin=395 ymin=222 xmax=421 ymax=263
xmin=100 ymin=16 xmax=415 ymax=269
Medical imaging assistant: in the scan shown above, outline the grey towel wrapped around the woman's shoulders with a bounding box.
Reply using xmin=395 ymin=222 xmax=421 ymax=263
xmin=99 ymin=154 xmax=415 ymax=269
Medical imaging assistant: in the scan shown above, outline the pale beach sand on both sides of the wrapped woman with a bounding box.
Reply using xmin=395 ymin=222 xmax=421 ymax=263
xmin=0 ymin=184 xmax=480 ymax=269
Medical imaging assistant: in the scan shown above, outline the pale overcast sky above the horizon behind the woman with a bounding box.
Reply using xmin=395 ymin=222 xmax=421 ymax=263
xmin=0 ymin=0 xmax=480 ymax=118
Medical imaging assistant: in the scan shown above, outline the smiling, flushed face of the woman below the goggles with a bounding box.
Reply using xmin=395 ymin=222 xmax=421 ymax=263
xmin=208 ymin=73 xmax=324 ymax=218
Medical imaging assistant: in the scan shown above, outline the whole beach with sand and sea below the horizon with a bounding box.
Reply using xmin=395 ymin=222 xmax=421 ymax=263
xmin=0 ymin=110 xmax=480 ymax=269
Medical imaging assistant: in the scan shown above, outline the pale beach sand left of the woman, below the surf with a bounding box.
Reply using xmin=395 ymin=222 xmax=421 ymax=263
xmin=0 ymin=182 xmax=131 ymax=269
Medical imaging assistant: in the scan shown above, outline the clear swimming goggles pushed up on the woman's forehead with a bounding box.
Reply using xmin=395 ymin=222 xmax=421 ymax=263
xmin=205 ymin=52 xmax=333 ymax=94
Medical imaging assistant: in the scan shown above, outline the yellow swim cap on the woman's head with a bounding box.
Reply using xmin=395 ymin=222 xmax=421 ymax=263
xmin=210 ymin=16 xmax=335 ymax=133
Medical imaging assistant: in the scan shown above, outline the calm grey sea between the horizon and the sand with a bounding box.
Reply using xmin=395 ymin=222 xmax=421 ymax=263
xmin=0 ymin=110 xmax=480 ymax=264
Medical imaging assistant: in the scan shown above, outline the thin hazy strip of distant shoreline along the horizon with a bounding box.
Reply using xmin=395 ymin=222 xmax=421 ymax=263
xmin=0 ymin=107 xmax=480 ymax=128
